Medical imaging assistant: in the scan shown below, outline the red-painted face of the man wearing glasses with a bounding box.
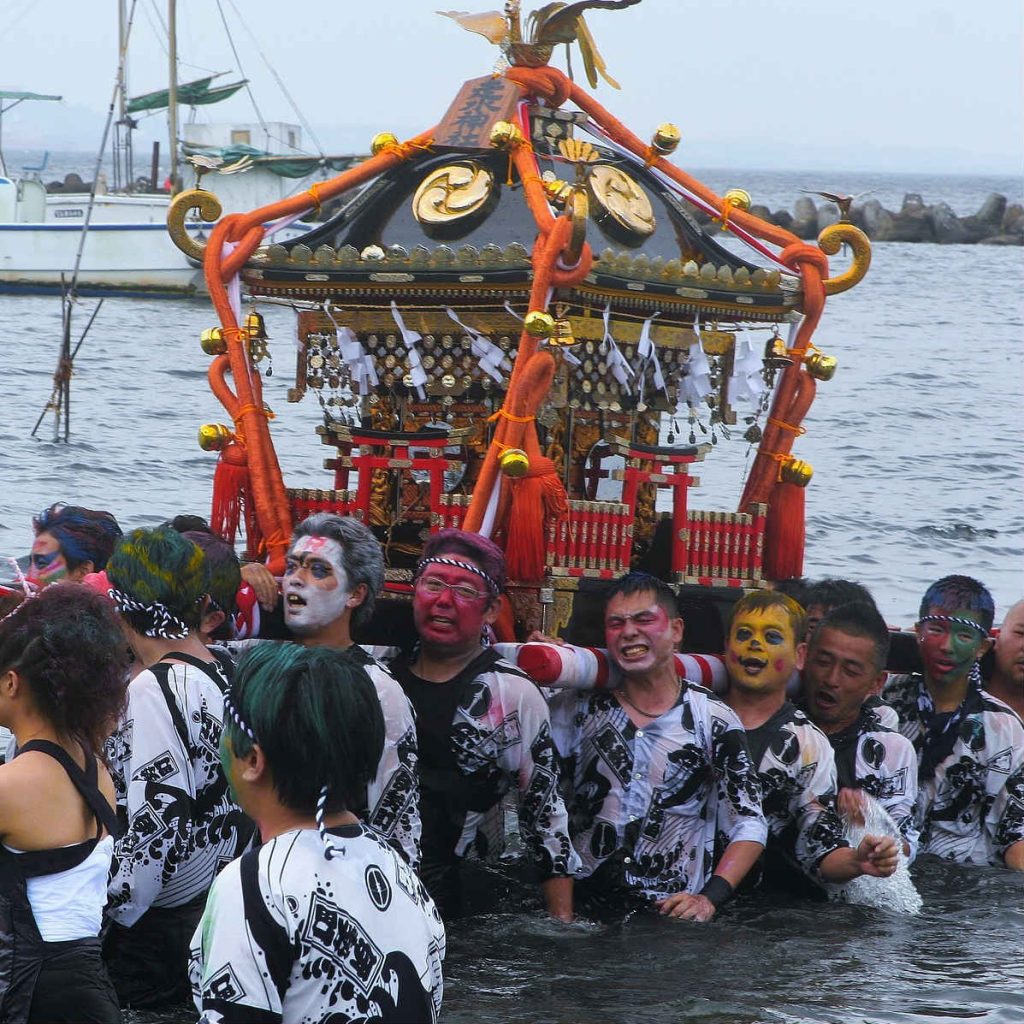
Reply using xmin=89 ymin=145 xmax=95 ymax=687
xmin=413 ymin=555 xmax=497 ymax=654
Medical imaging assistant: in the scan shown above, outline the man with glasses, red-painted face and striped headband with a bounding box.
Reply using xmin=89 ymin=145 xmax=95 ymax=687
xmin=391 ymin=529 xmax=579 ymax=920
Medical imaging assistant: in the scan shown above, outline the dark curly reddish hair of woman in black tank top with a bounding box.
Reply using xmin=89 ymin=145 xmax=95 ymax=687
xmin=0 ymin=582 xmax=128 ymax=752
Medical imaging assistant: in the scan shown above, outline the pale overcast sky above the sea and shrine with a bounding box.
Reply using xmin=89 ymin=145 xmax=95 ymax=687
xmin=0 ymin=0 xmax=1024 ymax=174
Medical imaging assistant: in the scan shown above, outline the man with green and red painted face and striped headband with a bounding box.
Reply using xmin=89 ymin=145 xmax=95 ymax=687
xmin=883 ymin=575 xmax=1024 ymax=870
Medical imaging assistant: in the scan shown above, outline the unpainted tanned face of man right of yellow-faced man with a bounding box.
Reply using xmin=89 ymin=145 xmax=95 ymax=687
xmin=804 ymin=626 xmax=880 ymax=732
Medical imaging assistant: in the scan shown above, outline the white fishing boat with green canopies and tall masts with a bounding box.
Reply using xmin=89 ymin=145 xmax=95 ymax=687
xmin=0 ymin=3 xmax=352 ymax=295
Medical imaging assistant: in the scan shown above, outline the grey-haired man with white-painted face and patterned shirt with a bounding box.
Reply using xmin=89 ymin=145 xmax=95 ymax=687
xmin=282 ymin=512 xmax=421 ymax=868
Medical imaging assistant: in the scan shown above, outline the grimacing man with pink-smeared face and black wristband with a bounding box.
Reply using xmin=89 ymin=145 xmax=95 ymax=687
xmin=551 ymin=572 xmax=767 ymax=922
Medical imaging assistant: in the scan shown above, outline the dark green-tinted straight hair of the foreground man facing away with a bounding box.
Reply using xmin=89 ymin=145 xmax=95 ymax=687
xmin=224 ymin=647 xmax=384 ymax=814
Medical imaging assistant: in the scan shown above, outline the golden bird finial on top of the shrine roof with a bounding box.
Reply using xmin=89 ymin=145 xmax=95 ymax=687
xmin=437 ymin=0 xmax=640 ymax=89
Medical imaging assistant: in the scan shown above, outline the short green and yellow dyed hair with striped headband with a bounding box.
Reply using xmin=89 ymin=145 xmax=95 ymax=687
xmin=106 ymin=526 xmax=210 ymax=637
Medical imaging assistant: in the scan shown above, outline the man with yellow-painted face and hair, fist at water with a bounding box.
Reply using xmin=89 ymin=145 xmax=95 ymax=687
xmin=725 ymin=591 xmax=897 ymax=884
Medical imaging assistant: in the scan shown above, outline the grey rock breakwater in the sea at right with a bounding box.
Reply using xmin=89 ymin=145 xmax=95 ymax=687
xmin=697 ymin=193 xmax=1024 ymax=246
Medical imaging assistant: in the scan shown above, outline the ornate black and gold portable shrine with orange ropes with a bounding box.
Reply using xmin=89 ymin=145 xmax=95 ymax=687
xmin=169 ymin=0 xmax=870 ymax=638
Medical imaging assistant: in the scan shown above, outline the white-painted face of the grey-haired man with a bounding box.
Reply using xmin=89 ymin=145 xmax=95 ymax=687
xmin=282 ymin=537 xmax=352 ymax=636
